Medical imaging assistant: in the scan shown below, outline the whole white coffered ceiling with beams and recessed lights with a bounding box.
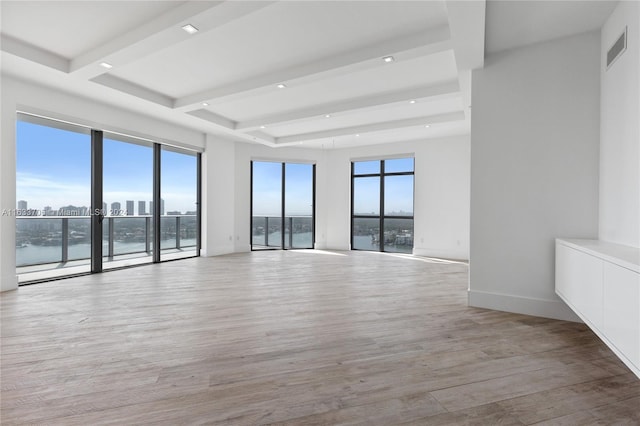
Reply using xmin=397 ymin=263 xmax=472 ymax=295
xmin=0 ymin=0 xmax=612 ymax=148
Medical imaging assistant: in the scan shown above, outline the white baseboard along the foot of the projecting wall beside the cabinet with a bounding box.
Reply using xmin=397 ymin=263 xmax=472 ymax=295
xmin=468 ymin=290 xmax=582 ymax=322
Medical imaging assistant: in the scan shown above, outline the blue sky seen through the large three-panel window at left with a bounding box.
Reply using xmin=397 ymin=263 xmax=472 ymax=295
xmin=16 ymin=121 xmax=196 ymax=214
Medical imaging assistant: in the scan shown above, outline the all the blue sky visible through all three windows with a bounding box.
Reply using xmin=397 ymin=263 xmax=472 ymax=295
xmin=16 ymin=121 xmax=413 ymax=216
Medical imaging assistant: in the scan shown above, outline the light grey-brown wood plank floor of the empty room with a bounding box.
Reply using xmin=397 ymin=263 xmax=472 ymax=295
xmin=0 ymin=251 xmax=640 ymax=425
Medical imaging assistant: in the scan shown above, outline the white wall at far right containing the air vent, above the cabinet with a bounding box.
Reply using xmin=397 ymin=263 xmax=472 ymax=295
xmin=599 ymin=1 xmax=640 ymax=247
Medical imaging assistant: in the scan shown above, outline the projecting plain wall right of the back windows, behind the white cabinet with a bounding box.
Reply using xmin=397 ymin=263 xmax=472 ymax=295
xmin=469 ymin=32 xmax=600 ymax=320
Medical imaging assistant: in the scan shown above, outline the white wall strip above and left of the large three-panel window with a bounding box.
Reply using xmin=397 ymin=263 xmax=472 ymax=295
xmin=0 ymin=75 xmax=205 ymax=291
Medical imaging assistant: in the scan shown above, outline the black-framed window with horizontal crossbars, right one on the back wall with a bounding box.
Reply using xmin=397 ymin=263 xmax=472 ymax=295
xmin=351 ymin=158 xmax=414 ymax=253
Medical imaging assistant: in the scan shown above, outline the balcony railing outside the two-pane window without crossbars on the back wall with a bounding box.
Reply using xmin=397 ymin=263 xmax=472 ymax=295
xmin=251 ymin=215 xmax=313 ymax=248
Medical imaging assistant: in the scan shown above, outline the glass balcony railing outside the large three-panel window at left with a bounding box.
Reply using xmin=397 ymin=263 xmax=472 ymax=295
xmin=16 ymin=215 xmax=197 ymax=267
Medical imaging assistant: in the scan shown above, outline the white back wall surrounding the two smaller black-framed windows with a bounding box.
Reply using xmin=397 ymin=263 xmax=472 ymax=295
xmin=228 ymin=137 xmax=469 ymax=259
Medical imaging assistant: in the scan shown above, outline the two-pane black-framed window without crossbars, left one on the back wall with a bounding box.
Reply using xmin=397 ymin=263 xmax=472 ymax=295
xmin=251 ymin=161 xmax=315 ymax=250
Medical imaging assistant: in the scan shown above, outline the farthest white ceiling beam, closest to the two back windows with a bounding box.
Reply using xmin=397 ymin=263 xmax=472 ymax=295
xmin=275 ymin=111 xmax=464 ymax=144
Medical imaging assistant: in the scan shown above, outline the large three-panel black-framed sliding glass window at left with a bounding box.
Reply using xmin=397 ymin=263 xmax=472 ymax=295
xmin=15 ymin=113 xmax=200 ymax=283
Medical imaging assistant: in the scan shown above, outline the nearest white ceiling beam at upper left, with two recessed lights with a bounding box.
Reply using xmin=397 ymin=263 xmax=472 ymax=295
xmin=70 ymin=1 xmax=274 ymax=79
